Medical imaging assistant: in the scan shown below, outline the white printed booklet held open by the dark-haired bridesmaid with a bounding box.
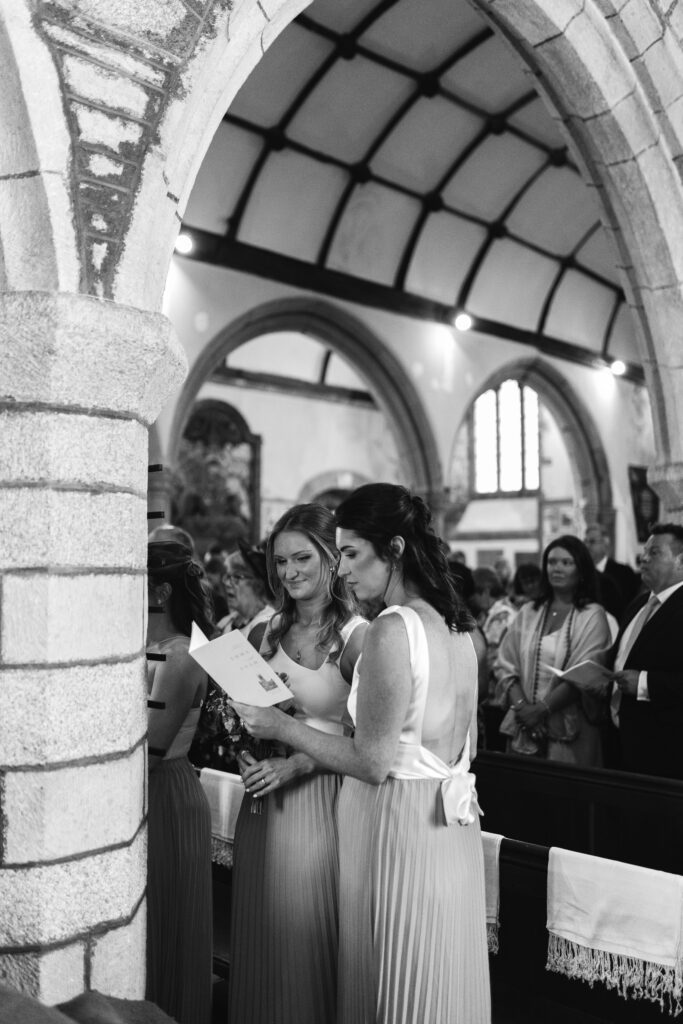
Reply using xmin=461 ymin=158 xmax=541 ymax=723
xmin=189 ymin=623 xmax=292 ymax=708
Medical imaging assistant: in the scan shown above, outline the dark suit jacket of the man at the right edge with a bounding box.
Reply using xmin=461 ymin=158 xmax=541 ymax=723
xmin=610 ymin=587 xmax=683 ymax=779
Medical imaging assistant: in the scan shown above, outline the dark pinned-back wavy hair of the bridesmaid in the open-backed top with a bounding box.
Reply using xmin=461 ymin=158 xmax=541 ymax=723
xmin=336 ymin=483 xmax=474 ymax=633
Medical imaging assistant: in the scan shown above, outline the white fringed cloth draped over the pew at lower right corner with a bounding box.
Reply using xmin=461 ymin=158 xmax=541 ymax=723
xmin=546 ymin=848 xmax=683 ymax=1017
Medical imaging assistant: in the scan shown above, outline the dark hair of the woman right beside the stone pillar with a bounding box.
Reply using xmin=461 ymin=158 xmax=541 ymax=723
xmin=147 ymin=541 xmax=216 ymax=639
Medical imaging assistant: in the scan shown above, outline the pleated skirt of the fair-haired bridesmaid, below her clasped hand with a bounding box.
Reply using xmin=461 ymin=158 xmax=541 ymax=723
xmin=228 ymin=774 xmax=341 ymax=1024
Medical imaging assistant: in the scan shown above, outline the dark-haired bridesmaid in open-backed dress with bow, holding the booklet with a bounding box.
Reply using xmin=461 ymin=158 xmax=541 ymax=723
xmin=237 ymin=483 xmax=490 ymax=1024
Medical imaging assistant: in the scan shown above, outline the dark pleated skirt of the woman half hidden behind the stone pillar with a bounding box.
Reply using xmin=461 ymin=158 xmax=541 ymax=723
xmin=145 ymin=758 xmax=212 ymax=1024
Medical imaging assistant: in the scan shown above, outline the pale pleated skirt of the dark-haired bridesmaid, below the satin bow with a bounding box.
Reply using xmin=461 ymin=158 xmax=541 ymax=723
xmin=337 ymin=778 xmax=490 ymax=1024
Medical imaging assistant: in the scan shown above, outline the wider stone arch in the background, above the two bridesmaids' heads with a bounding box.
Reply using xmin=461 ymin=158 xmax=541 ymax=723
xmin=168 ymin=299 xmax=442 ymax=502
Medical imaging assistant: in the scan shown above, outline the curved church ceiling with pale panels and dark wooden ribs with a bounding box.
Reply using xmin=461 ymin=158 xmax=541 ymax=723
xmin=184 ymin=0 xmax=639 ymax=377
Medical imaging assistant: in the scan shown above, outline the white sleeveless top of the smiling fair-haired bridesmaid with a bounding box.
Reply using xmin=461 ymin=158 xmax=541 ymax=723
xmin=260 ymin=615 xmax=366 ymax=735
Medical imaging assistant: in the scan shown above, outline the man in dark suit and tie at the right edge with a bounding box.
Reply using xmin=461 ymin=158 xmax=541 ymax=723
xmin=611 ymin=523 xmax=683 ymax=779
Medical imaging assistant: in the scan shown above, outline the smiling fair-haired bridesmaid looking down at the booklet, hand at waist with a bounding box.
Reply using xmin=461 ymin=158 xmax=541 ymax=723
xmin=229 ymin=504 xmax=367 ymax=1024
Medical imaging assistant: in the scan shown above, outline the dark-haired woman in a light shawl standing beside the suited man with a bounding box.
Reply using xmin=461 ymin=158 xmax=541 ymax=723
xmin=496 ymin=535 xmax=610 ymax=767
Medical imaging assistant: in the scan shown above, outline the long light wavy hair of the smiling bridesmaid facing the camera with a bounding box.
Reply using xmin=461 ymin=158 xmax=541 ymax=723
xmin=265 ymin=503 xmax=357 ymax=662
